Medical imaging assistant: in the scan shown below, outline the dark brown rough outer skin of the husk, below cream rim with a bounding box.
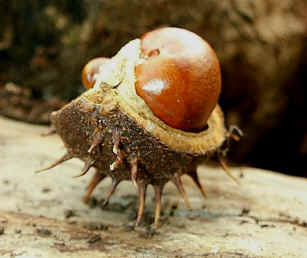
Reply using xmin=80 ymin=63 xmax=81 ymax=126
xmin=52 ymin=88 xmax=225 ymax=185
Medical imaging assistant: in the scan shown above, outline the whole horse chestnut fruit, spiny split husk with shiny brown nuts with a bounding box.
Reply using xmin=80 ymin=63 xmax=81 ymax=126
xmin=41 ymin=28 xmax=229 ymax=227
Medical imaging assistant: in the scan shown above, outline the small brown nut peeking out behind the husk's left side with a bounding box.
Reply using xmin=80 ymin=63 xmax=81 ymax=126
xmin=81 ymin=57 xmax=110 ymax=89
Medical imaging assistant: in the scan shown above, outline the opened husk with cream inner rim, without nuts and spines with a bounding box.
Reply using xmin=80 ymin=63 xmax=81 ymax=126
xmin=52 ymin=39 xmax=226 ymax=185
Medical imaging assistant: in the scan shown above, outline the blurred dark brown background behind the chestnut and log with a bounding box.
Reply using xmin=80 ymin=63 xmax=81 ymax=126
xmin=0 ymin=0 xmax=307 ymax=177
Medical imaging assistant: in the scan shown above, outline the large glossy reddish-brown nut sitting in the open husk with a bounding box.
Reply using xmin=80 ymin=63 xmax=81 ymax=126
xmin=135 ymin=28 xmax=221 ymax=132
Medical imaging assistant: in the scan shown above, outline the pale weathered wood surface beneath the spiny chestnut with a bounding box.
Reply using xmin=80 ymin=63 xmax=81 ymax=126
xmin=0 ymin=118 xmax=307 ymax=257
